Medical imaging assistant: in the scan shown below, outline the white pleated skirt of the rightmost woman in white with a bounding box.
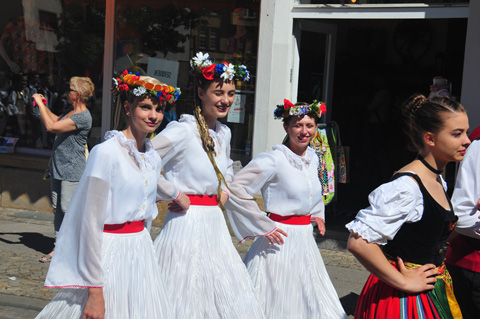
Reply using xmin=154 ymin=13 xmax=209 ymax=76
xmin=244 ymin=222 xmax=348 ymax=319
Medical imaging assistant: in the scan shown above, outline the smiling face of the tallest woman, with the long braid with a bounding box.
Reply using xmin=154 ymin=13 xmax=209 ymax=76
xmin=198 ymin=79 xmax=235 ymax=119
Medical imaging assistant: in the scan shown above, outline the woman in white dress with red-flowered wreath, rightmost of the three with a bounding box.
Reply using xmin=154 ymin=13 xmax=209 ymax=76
xmin=226 ymin=100 xmax=347 ymax=319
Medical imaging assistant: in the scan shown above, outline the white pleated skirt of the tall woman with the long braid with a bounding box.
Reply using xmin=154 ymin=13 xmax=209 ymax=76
xmin=155 ymin=205 xmax=264 ymax=319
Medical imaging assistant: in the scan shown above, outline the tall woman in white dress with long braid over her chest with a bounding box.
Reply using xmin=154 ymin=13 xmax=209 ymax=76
xmin=152 ymin=52 xmax=263 ymax=319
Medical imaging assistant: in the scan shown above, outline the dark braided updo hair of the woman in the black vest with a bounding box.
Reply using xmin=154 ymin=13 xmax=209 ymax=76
xmin=402 ymin=94 xmax=466 ymax=151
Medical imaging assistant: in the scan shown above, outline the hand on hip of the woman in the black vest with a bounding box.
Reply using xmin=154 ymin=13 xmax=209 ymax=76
xmin=397 ymin=257 xmax=440 ymax=293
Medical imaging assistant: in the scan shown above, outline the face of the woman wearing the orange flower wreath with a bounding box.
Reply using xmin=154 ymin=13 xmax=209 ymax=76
xmin=125 ymin=95 xmax=165 ymax=135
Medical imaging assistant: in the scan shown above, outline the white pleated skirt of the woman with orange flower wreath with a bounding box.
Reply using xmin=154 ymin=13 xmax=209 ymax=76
xmin=36 ymin=229 xmax=174 ymax=319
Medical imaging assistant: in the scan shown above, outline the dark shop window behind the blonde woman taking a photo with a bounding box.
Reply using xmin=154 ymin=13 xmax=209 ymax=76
xmin=0 ymin=0 xmax=105 ymax=155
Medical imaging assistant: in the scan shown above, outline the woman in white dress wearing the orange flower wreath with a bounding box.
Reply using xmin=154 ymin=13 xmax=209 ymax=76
xmin=37 ymin=71 xmax=179 ymax=319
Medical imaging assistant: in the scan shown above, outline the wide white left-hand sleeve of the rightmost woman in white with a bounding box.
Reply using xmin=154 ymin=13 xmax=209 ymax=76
xmin=225 ymin=153 xmax=277 ymax=242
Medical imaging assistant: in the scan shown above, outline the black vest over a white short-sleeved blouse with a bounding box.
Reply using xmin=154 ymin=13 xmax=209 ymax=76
xmin=383 ymin=173 xmax=458 ymax=267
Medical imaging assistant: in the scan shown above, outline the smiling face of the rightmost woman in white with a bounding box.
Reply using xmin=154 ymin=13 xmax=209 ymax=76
xmin=283 ymin=115 xmax=317 ymax=156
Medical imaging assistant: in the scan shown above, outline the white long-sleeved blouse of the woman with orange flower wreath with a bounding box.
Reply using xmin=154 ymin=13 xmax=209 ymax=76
xmin=45 ymin=131 xmax=171 ymax=287
